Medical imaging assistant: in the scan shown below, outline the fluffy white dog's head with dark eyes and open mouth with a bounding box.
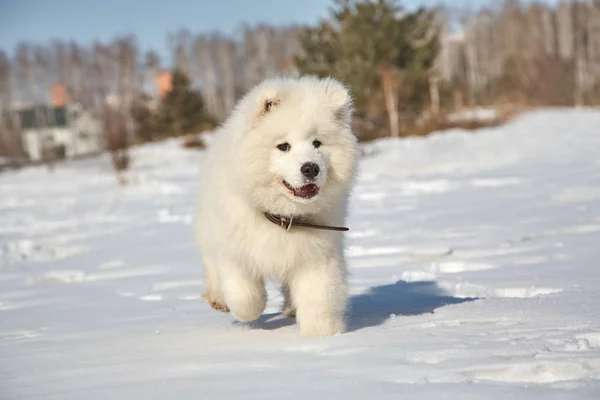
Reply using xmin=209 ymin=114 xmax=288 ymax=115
xmin=235 ymin=77 xmax=357 ymax=215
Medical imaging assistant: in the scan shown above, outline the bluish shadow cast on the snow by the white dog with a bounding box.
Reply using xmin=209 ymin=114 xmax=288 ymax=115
xmin=239 ymin=280 xmax=477 ymax=332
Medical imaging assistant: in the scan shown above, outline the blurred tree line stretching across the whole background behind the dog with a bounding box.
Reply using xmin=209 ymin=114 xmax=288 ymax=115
xmin=0 ymin=0 xmax=600 ymax=159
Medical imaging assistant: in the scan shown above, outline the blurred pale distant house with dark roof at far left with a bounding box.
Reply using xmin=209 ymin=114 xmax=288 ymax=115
xmin=15 ymin=103 xmax=104 ymax=161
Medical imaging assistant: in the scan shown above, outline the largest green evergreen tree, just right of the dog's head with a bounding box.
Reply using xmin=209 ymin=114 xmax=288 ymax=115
xmin=296 ymin=0 xmax=438 ymax=137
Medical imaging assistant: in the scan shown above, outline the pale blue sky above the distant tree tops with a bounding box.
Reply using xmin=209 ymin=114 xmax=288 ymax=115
xmin=0 ymin=0 xmax=560 ymax=59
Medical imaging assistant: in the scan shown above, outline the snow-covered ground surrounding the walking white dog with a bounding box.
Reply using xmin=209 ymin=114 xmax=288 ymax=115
xmin=0 ymin=109 xmax=600 ymax=400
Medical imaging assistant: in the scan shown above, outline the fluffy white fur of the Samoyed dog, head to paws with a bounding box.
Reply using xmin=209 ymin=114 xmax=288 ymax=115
xmin=194 ymin=77 xmax=357 ymax=336
